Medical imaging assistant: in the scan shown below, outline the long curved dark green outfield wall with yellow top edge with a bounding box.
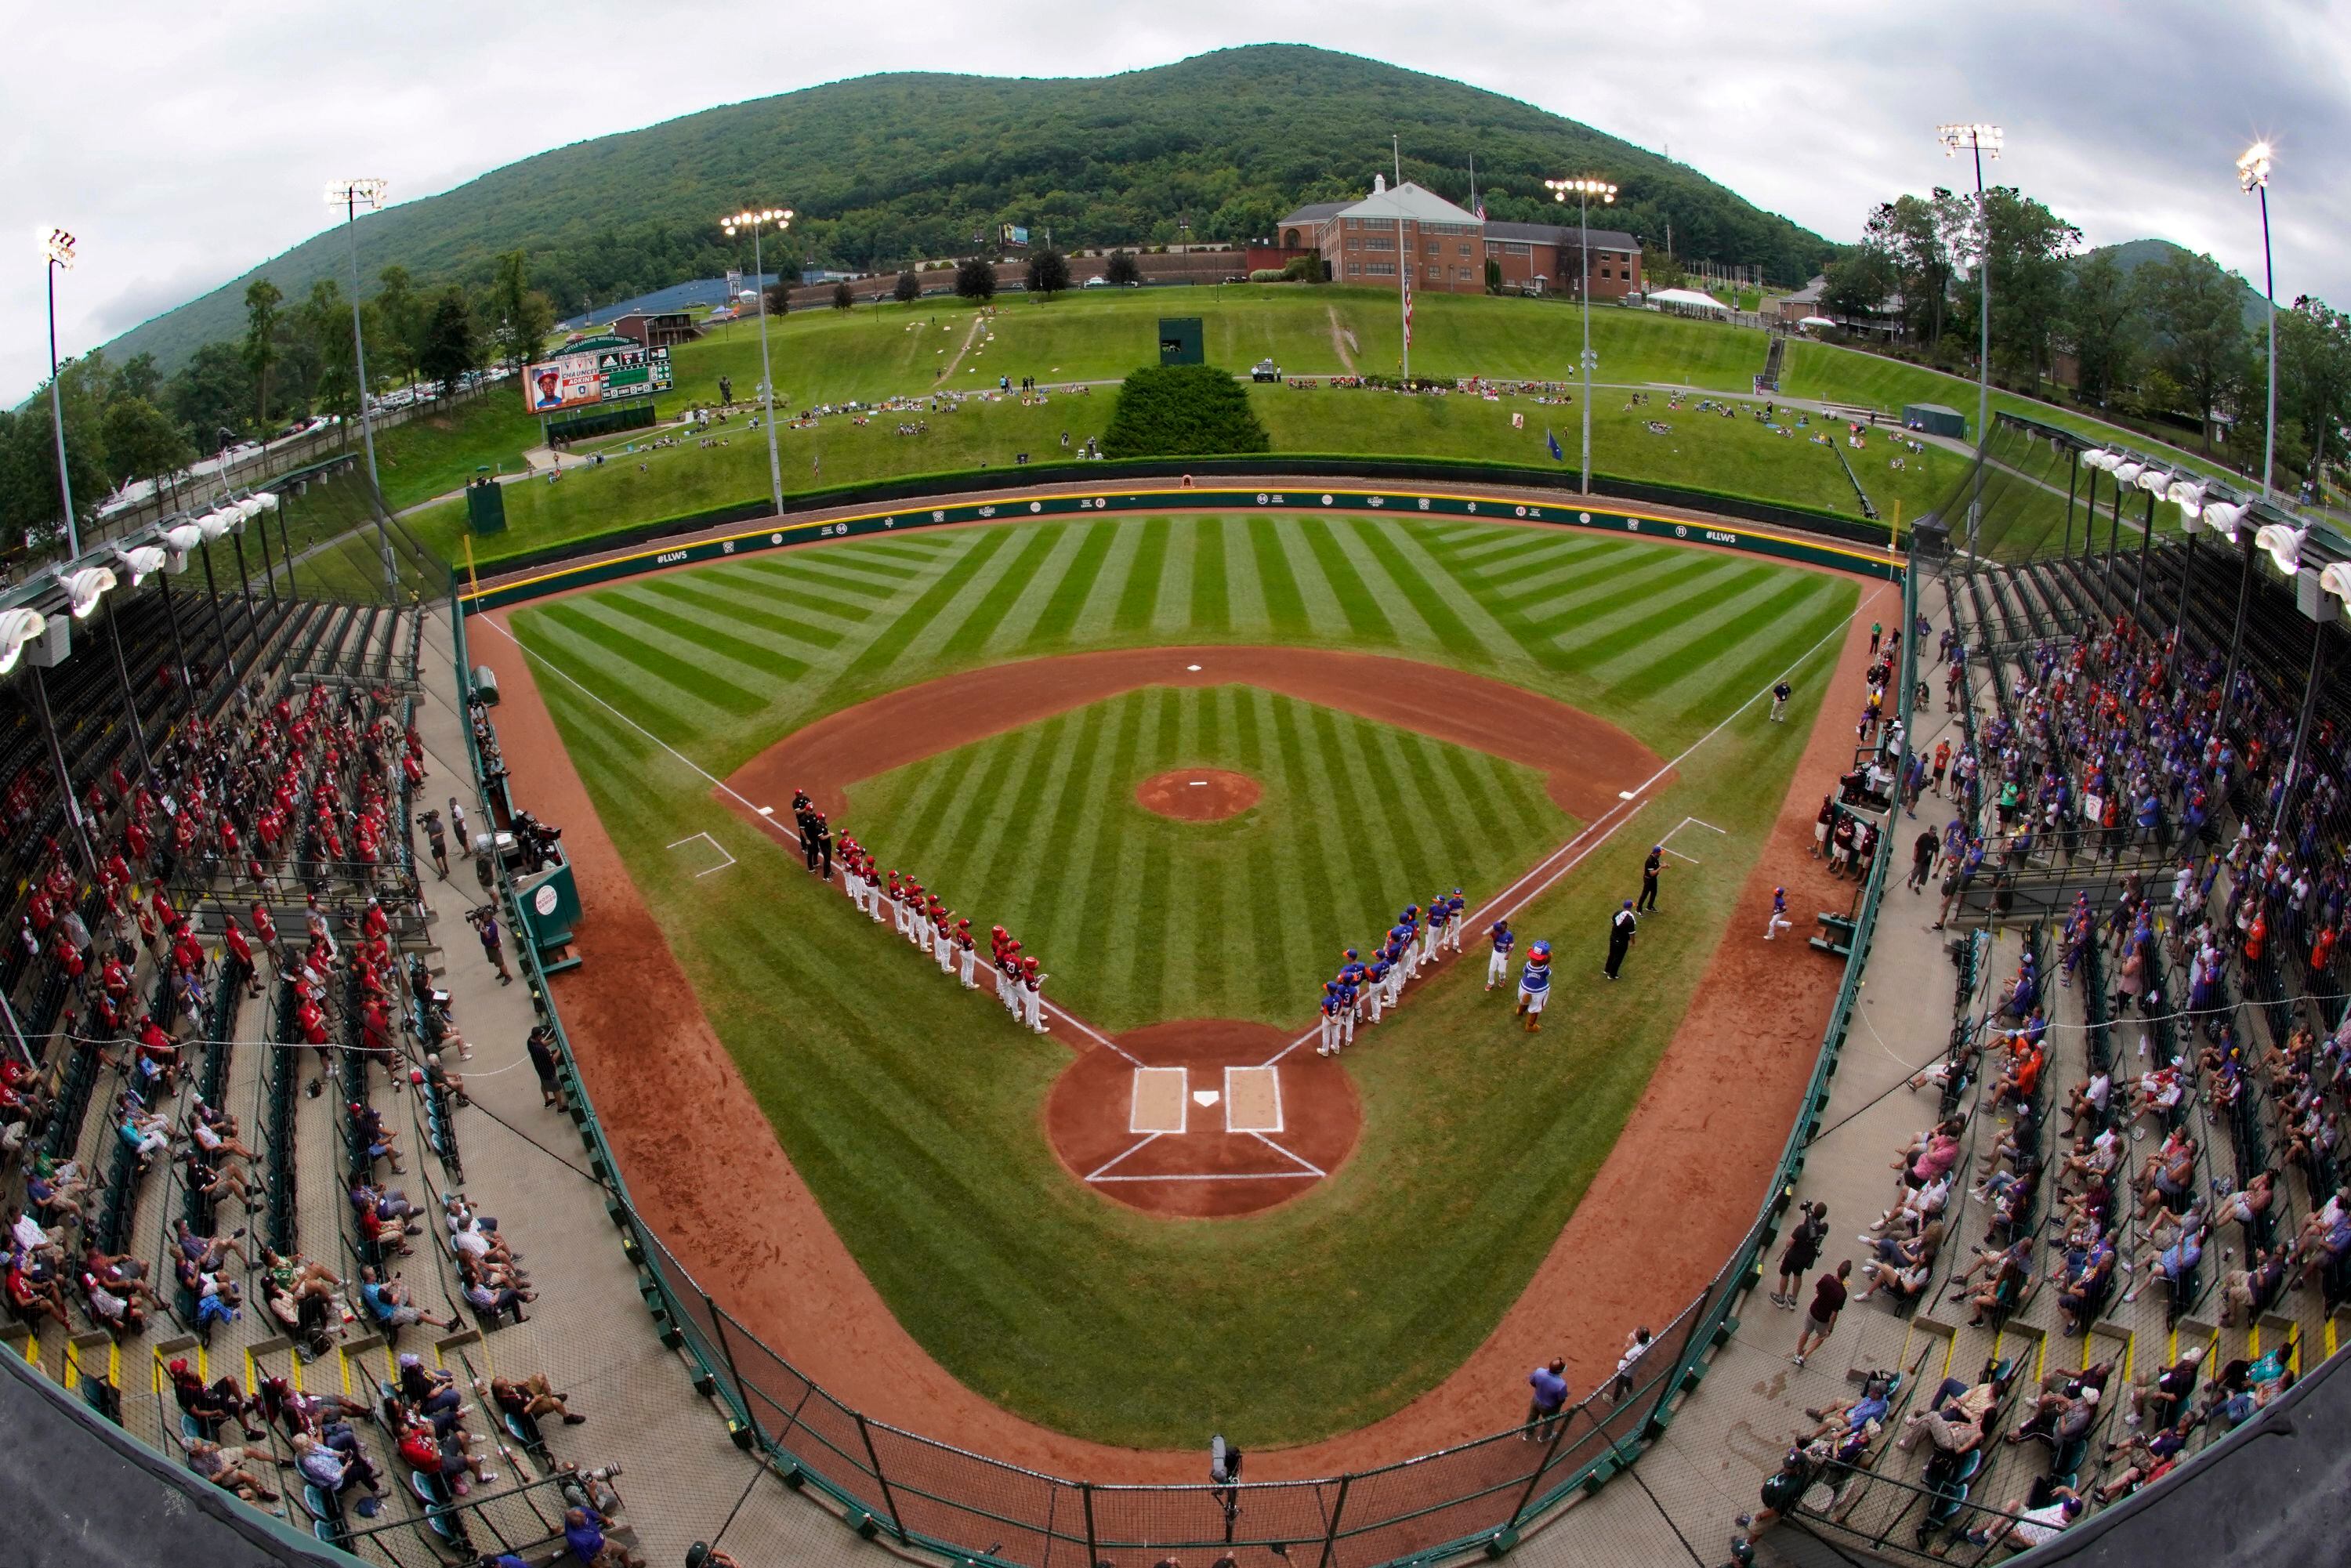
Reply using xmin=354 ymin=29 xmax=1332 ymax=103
xmin=458 ymin=484 xmax=1902 ymax=614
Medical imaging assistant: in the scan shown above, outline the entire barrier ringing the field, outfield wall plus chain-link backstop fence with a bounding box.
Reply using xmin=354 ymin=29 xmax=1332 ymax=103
xmin=437 ymin=489 xmax=1916 ymax=1568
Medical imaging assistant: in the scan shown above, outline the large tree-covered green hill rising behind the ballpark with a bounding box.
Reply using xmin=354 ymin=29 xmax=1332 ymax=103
xmin=106 ymin=45 xmax=1831 ymax=374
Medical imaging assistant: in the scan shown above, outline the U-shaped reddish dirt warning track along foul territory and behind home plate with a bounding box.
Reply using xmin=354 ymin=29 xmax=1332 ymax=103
xmin=473 ymin=545 xmax=1900 ymax=1483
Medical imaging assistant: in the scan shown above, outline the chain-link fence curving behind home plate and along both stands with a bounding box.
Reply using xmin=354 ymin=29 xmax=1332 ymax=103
xmin=449 ymin=531 xmax=1918 ymax=1568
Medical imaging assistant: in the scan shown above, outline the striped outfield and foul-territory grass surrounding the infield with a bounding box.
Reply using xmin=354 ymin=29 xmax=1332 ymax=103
xmin=510 ymin=517 xmax=1855 ymax=1446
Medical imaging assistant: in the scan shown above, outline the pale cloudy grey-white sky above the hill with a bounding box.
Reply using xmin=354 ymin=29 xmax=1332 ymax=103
xmin=0 ymin=0 xmax=2351 ymax=400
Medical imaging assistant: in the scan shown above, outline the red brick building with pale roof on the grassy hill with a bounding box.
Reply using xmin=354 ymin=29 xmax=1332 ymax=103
xmin=1279 ymin=179 xmax=1641 ymax=299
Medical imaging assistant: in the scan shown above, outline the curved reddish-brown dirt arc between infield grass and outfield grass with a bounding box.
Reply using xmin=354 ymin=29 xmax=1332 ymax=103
xmin=726 ymin=646 xmax=1667 ymax=823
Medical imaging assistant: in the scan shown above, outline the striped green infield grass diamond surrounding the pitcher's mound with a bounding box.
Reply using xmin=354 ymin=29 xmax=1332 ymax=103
xmin=849 ymin=686 xmax=1578 ymax=1030
